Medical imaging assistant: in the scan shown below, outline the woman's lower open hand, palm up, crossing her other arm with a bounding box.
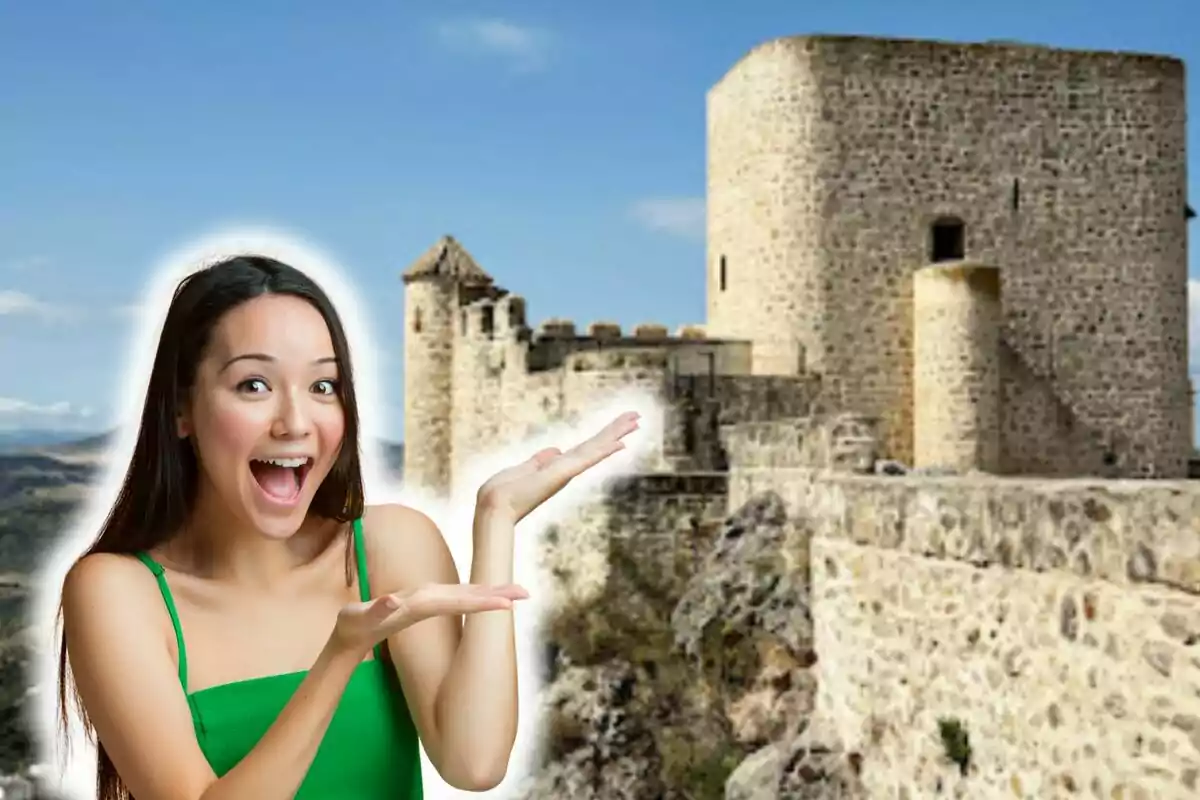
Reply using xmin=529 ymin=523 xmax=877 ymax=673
xmin=332 ymin=583 xmax=529 ymax=654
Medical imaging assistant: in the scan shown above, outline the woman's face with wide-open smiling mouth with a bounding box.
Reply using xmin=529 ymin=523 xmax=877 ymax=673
xmin=179 ymin=295 xmax=346 ymax=539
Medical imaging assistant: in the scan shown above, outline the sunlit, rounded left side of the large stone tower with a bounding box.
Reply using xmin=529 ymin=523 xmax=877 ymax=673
xmin=706 ymin=40 xmax=829 ymax=383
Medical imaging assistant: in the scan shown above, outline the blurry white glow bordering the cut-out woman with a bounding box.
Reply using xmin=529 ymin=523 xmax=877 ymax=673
xmin=30 ymin=227 xmax=662 ymax=800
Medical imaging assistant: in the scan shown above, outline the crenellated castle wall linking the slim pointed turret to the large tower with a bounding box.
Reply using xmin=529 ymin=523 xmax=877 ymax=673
xmin=446 ymin=316 xmax=821 ymax=491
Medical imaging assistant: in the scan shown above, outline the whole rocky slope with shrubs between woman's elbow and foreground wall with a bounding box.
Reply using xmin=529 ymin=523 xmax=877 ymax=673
xmin=522 ymin=476 xmax=857 ymax=800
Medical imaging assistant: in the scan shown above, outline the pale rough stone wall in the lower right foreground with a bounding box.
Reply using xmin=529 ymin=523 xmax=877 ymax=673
xmin=796 ymin=474 xmax=1200 ymax=800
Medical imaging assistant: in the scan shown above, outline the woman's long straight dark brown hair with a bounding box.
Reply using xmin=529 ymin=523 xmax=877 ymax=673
xmin=59 ymin=255 xmax=364 ymax=800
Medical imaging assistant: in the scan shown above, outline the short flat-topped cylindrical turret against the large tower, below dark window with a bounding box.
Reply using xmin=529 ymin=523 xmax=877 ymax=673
xmin=913 ymin=263 xmax=1003 ymax=473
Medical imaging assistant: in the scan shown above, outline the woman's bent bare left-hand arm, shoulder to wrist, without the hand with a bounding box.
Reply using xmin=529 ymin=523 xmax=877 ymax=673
xmin=64 ymin=554 xmax=361 ymax=800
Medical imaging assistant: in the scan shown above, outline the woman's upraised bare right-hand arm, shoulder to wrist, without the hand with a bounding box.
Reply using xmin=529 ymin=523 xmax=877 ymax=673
xmin=364 ymin=505 xmax=517 ymax=792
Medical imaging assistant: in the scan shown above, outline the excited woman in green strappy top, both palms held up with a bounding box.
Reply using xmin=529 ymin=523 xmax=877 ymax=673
xmin=51 ymin=255 xmax=637 ymax=800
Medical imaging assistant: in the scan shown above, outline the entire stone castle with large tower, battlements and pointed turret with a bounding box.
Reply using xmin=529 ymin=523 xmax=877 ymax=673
xmin=404 ymin=32 xmax=1192 ymax=487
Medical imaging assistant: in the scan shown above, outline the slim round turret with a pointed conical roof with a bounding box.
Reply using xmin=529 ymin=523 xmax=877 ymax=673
xmin=403 ymin=236 xmax=492 ymax=494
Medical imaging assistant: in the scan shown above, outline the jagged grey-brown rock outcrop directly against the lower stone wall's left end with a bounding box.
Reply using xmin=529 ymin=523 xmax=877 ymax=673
xmin=673 ymin=493 xmax=862 ymax=800
